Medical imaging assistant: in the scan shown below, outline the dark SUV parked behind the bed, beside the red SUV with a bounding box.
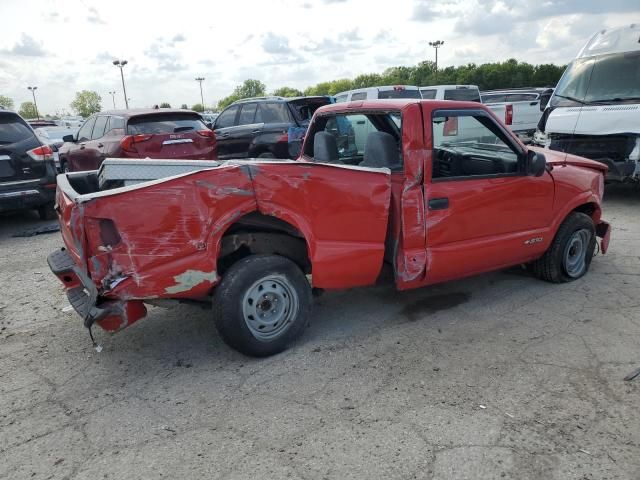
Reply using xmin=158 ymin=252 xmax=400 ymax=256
xmin=213 ymin=96 xmax=332 ymax=159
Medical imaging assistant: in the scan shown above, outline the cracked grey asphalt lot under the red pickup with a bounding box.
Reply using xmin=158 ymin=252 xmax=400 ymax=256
xmin=0 ymin=186 xmax=640 ymax=480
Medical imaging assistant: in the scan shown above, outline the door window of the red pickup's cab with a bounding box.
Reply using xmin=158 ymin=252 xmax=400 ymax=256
xmin=431 ymin=112 xmax=520 ymax=181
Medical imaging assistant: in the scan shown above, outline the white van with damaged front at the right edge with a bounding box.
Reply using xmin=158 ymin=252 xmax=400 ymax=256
xmin=534 ymin=23 xmax=640 ymax=181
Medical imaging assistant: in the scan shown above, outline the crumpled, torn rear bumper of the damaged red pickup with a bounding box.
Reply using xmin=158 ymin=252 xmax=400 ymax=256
xmin=47 ymin=248 xmax=147 ymax=332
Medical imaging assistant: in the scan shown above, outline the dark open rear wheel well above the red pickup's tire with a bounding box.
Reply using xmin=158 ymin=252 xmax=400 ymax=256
xmin=218 ymin=212 xmax=311 ymax=274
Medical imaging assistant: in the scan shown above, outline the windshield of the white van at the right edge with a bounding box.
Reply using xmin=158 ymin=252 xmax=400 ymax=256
xmin=552 ymin=51 xmax=640 ymax=107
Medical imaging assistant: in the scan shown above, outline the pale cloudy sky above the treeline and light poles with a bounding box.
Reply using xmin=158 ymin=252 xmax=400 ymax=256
xmin=0 ymin=0 xmax=640 ymax=114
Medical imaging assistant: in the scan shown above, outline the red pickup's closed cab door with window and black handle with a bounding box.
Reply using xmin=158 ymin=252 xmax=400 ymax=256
xmin=423 ymin=105 xmax=554 ymax=283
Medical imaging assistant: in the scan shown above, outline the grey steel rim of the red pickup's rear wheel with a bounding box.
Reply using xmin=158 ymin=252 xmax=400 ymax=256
xmin=242 ymin=275 xmax=298 ymax=342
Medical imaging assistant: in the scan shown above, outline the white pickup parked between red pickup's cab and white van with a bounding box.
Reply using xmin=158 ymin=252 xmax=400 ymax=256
xmin=480 ymin=88 xmax=553 ymax=142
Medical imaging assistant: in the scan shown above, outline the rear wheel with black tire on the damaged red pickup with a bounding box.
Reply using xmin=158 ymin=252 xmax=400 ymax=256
xmin=213 ymin=255 xmax=312 ymax=357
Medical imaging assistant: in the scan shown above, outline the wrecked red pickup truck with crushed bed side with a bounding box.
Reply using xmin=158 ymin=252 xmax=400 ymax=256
xmin=48 ymin=100 xmax=610 ymax=356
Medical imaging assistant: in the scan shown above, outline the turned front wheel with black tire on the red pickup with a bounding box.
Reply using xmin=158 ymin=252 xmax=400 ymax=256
xmin=531 ymin=212 xmax=596 ymax=283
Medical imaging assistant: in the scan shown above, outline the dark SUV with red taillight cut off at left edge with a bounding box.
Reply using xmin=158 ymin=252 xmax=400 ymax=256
xmin=0 ymin=107 xmax=56 ymax=220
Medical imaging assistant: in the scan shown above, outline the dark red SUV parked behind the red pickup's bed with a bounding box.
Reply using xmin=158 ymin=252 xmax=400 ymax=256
xmin=59 ymin=108 xmax=216 ymax=171
